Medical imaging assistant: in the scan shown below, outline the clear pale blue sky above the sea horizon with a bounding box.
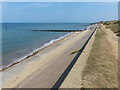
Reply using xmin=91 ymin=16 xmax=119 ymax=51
xmin=2 ymin=2 xmax=118 ymax=23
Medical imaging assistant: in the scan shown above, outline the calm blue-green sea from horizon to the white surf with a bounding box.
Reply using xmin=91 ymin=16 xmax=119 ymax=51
xmin=0 ymin=23 xmax=90 ymax=68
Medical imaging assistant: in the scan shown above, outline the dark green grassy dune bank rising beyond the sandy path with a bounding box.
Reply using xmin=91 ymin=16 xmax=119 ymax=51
xmin=103 ymin=20 xmax=120 ymax=36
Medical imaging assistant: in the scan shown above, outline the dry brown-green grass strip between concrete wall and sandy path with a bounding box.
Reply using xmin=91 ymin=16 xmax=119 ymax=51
xmin=83 ymin=24 xmax=117 ymax=88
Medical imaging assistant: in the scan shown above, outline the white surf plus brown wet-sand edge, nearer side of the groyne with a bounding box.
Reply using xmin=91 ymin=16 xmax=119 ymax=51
xmin=0 ymin=31 xmax=74 ymax=72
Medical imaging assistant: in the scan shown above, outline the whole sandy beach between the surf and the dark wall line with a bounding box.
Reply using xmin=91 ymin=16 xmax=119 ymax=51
xmin=1 ymin=23 xmax=97 ymax=88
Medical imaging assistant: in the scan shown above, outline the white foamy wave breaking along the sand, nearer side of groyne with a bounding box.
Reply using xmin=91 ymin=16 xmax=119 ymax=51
xmin=0 ymin=32 xmax=72 ymax=71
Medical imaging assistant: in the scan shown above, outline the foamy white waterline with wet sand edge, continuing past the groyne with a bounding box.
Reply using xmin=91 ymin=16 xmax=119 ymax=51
xmin=0 ymin=24 xmax=94 ymax=72
